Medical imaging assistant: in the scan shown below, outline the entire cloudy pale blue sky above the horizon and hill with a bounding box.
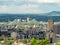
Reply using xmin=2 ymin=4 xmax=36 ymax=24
xmin=0 ymin=0 xmax=60 ymax=14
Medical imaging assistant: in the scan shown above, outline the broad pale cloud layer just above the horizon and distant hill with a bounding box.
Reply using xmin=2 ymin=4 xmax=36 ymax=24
xmin=0 ymin=3 xmax=60 ymax=14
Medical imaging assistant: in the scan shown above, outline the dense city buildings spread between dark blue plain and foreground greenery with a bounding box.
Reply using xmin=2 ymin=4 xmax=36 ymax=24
xmin=0 ymin=18 xmax=60 ymax=45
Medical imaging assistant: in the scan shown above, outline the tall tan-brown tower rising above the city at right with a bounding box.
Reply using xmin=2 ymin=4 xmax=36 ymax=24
xmin=46 ymin=19 xmax=55 ymax=43
